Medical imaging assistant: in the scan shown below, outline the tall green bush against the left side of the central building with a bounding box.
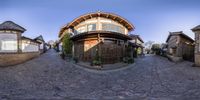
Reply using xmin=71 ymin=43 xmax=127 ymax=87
xmin=62 ymin=33 xmax=72 ymax=55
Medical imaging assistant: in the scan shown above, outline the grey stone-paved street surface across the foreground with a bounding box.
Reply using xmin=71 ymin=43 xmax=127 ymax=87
xmin=0 ymin=50 xmax=200 ymax=100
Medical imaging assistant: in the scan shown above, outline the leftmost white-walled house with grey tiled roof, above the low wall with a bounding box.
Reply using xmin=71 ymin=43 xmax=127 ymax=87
xmin=0 ymin=21 xmax=26 ymax=53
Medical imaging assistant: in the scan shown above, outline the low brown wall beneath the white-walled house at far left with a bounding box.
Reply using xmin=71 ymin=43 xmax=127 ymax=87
xmin=0 ymin=52 xmax=40 ymax=67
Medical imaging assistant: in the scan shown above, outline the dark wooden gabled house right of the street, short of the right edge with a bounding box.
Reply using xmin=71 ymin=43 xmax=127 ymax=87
xmin=166 ymin=31 xmax=194 ymax=61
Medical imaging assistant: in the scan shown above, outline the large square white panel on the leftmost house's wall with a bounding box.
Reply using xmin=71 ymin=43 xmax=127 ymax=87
xmin=0 ymin=33 xmax=17 ymax=52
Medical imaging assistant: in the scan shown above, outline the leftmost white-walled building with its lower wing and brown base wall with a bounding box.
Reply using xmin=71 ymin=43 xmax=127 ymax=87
xmin=0 ymin=21 xmax=39 ymax=66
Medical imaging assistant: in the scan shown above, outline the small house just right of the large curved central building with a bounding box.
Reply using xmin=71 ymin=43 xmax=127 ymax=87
xmin=129 ymin=34 xmax=144 ymax=57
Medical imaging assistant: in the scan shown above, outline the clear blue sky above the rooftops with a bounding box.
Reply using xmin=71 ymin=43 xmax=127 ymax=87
xmin=0 ymin=0 xmax=200 ymax=43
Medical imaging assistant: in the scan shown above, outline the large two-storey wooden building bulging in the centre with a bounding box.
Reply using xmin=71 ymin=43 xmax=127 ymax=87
xmin=59 ymin=12 xmax=134 ymax=63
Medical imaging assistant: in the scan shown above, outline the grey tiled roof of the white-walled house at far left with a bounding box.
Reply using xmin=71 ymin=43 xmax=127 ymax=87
xmin=0 ymin=21 xmax=26 ymax=32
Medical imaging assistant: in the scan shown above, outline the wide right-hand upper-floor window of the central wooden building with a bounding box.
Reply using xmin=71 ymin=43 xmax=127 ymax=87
xmin=102 ymin=23 xmax=124 ymax=33
